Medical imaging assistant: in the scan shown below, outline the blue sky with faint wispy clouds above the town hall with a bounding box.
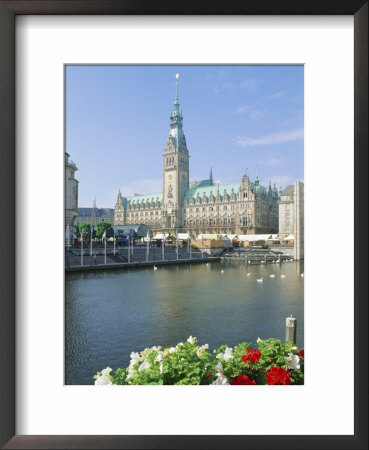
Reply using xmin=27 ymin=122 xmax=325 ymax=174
xmin=66 ymin=65 xmax=304 ymax=208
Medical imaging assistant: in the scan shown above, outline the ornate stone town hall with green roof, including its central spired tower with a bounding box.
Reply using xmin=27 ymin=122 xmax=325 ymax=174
xmin=114 ymin=84 xmax=279 ymax=235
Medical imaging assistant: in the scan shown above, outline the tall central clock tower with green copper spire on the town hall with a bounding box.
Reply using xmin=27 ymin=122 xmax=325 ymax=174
xmin=162 ymin=74 xmax=190 ymax=232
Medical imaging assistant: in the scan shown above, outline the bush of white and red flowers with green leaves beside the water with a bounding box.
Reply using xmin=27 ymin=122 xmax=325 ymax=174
xmin=94 ymin=336 xmax=304 ymax=386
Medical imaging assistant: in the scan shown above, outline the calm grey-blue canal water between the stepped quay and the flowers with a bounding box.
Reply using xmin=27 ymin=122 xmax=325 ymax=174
xmin=65 ymin=260 xmax=304 ymax=385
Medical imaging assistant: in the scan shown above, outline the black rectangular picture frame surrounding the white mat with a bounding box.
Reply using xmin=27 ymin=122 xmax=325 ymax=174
xmin=0 ymin=0 xmax=368 ymax=449
